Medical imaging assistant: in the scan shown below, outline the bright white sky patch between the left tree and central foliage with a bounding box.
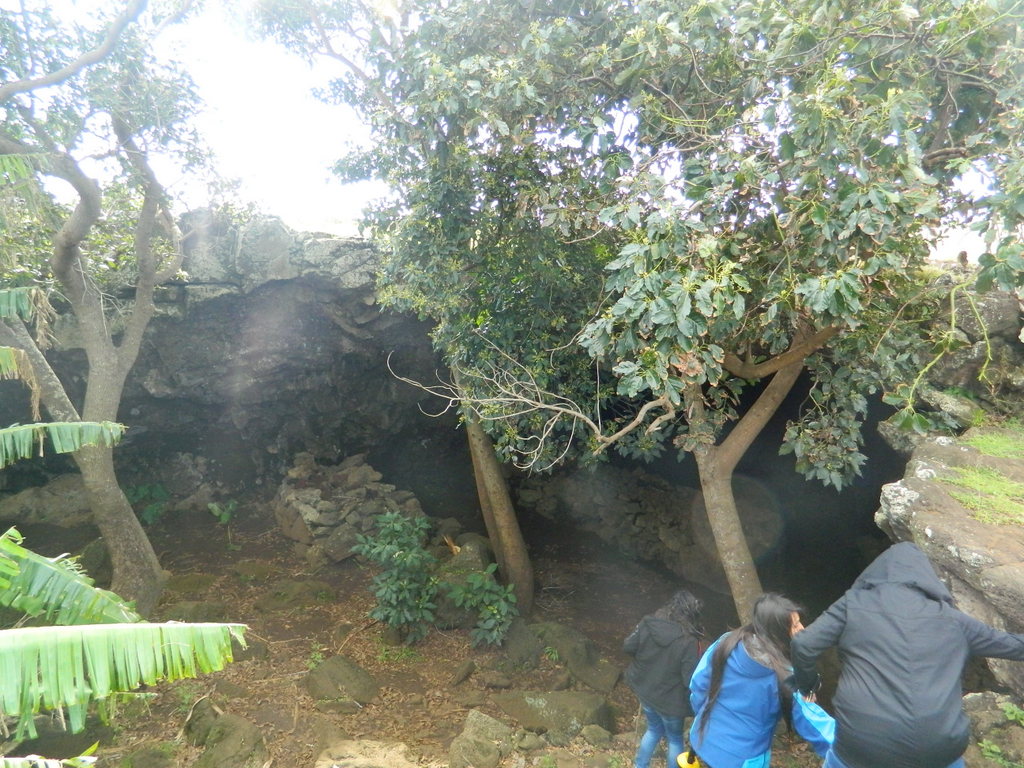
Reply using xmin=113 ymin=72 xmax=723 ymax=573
xmin=155 ymin=2 xmax=383 ymax=234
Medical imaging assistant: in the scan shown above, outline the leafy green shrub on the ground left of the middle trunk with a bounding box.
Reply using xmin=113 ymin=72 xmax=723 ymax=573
xmin=352 ymin=512 xmax=437 ymax=644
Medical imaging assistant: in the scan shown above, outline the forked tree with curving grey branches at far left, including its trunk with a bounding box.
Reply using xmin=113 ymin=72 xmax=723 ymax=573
xmin=0 ymin=0 xmax=207 ymax=614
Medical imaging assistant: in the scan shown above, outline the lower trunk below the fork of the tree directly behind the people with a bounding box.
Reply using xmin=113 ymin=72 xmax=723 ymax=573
xmin=695 ymin=449 xmax=762 ymax=624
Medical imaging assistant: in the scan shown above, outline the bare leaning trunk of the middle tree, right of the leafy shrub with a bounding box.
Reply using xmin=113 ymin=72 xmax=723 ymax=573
xmin=466 ymin=418 xmax=534 ymax=615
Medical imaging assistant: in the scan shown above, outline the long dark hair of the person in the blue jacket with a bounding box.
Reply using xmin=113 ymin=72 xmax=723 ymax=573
xmin=698 ymin=592 xmax=802 ymax=738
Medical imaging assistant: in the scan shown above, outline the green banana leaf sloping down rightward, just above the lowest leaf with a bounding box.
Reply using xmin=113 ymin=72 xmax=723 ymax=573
xmin=0 ymin=528 xmax=142 ymax=625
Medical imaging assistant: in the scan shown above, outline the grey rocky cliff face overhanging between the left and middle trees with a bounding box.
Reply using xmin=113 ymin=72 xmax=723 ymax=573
xmin=40 ymin=217 xmax=453 ymax=495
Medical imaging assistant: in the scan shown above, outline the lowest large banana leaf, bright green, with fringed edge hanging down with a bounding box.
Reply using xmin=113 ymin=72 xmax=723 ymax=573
xmin=0 ymin=622 xmax=246 ymax=738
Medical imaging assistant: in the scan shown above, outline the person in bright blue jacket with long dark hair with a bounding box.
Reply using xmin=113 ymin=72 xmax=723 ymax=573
xmin=690 ymin=593 xmax=836 ymax=768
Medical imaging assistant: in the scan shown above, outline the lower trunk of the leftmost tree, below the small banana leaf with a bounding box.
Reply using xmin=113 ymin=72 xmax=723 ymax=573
xmin=75 ymin=446 xmax=167 ymax=616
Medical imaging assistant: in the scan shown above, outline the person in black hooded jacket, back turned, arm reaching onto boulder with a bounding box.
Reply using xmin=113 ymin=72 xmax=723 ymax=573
xmin=792 ymin=542 xmax=1024 ymax=768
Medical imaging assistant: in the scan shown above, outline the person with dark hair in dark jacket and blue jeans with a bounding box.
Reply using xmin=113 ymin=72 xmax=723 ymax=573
xmin=623 ymin=590 xmax=703 ymax=768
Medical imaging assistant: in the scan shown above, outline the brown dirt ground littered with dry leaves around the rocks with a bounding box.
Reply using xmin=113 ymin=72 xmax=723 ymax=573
xmin=14 ymin=503 xmax=819 ymax=768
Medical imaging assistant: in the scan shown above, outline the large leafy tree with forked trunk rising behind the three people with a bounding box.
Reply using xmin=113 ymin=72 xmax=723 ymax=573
xmin=251 ymin=0 xmax=1024 ymax=617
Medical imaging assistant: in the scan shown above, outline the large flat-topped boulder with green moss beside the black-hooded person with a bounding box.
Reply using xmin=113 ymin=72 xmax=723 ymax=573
xmin=876 ymin=427 xmax=1024 ymax=695
